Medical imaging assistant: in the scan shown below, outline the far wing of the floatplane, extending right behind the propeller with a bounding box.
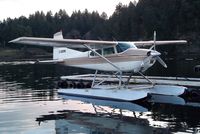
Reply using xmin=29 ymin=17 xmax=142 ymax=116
xmin=132 ymin=40 xmax=187 ymax=47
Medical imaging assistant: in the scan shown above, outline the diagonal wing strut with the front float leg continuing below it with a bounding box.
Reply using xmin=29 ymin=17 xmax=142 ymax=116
xmin=83 ymin=44 xmax=122 ymax=88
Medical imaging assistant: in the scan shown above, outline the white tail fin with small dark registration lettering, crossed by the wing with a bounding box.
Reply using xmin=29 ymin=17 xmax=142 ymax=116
xmin=53 ymin=31 xmax=83 ymax=60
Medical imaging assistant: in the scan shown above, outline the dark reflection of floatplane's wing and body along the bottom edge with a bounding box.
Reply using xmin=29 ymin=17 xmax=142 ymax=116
xmin=37 ymin=111 xmax=161 ymax=134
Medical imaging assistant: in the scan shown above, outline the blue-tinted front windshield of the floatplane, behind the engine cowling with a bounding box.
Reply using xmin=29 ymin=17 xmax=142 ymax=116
xmin=116 ymin=42 xmax=135 ymax=53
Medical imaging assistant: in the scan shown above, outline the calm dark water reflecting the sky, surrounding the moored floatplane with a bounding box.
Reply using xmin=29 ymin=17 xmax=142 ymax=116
xmin=0 ymin=63 xmax=200 ymax=134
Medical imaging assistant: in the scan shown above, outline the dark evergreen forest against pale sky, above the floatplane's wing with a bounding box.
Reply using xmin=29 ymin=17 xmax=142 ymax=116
xmin=0 ymin=0 xmax=200 ymax=49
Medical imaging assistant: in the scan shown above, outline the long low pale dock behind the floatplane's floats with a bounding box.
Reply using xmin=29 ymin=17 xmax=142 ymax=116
xmin=61 ymin=74 xmax=200 ymax=87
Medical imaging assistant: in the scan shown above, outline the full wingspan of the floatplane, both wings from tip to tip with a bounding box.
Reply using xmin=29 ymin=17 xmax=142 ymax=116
xmin=9 ymin=31 xmax=187 ymax=49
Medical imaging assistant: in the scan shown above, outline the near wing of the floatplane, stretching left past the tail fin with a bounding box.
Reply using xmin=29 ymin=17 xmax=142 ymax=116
xmin=9 ymin=37 xmax=117 ymax=49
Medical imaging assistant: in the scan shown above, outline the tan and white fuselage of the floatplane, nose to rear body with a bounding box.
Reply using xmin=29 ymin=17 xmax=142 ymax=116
xmin=59 ymin=42 xmax=160 ymax=72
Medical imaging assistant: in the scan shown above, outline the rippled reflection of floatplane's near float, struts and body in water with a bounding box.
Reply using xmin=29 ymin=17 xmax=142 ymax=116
xmin=36 ymin=96 xmax=168 ymax=134
